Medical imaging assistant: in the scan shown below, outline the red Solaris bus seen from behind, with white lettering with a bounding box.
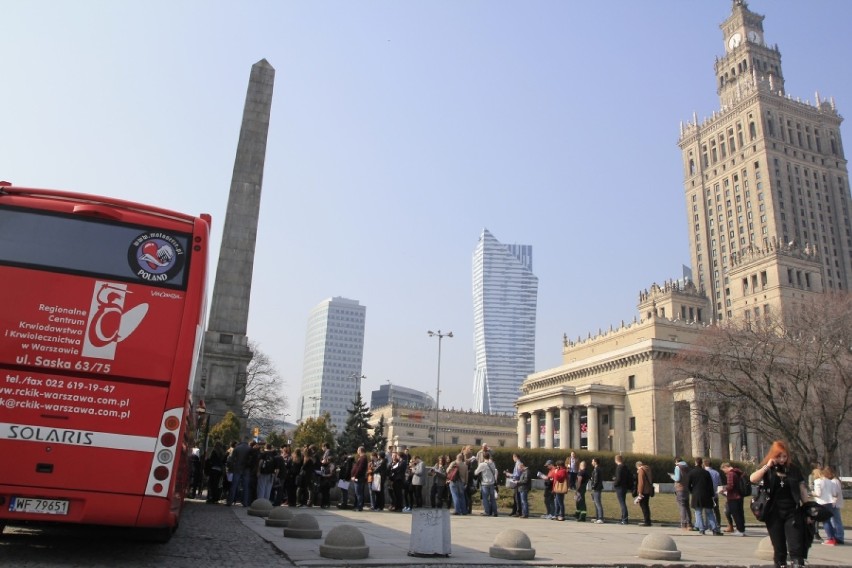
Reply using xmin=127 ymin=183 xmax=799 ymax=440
xmin=0 ymin=182 xmax=210 ymax=541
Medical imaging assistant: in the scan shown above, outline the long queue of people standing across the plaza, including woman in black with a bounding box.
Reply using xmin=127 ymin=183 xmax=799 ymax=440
xmin=188 ymin=439 xmax=844 ymax=567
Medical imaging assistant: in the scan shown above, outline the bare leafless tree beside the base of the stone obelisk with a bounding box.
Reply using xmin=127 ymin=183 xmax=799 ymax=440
xmin=243 ymin=342 xmax=287 ymax=433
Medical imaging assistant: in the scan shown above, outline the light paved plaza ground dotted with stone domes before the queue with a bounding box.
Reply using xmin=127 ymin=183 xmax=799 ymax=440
xmin=233 ymin=508 xmax=852 ymax=568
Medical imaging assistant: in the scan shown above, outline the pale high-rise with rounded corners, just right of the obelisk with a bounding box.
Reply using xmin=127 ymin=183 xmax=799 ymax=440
xmin=299 ymin=297 xmax=367 ymax=432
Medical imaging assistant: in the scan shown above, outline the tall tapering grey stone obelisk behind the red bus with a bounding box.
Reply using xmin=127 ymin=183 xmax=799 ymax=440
xmin=193 ymin=59 xmax=275 ymax=425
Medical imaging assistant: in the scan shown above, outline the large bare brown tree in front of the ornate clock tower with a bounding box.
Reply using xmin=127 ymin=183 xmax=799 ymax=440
xmin=669 ymin=293 xmax=852 ymax=466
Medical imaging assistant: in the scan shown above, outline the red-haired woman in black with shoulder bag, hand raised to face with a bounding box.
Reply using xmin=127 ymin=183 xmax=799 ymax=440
xmin=749 ymin=440 xmax=809 ymax=568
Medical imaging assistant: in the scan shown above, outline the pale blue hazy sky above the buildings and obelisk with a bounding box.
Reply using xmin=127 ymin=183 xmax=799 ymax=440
xmin=0 ymin=0 xmax=852 ymax=419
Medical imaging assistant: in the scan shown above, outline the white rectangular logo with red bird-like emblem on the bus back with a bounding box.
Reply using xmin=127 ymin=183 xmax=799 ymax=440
xmin=82 ymin=280 xmax=148 ymax=360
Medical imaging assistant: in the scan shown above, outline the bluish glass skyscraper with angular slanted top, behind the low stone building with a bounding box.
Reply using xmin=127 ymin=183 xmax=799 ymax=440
xmin=473 ymin=229 xmax=538 ymax=413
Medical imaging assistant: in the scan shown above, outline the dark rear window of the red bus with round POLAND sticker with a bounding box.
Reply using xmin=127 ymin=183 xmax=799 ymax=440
xmin=0 ymin=207 xmax=190 ymax=290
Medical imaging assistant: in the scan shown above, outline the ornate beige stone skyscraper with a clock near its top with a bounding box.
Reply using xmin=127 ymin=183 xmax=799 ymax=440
xmin=678 ymin=0 xmax=852 ymax=321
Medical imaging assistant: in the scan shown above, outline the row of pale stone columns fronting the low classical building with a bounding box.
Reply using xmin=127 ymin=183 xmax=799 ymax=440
xmin=518 ymin=404 xmax=625 ymax=451
